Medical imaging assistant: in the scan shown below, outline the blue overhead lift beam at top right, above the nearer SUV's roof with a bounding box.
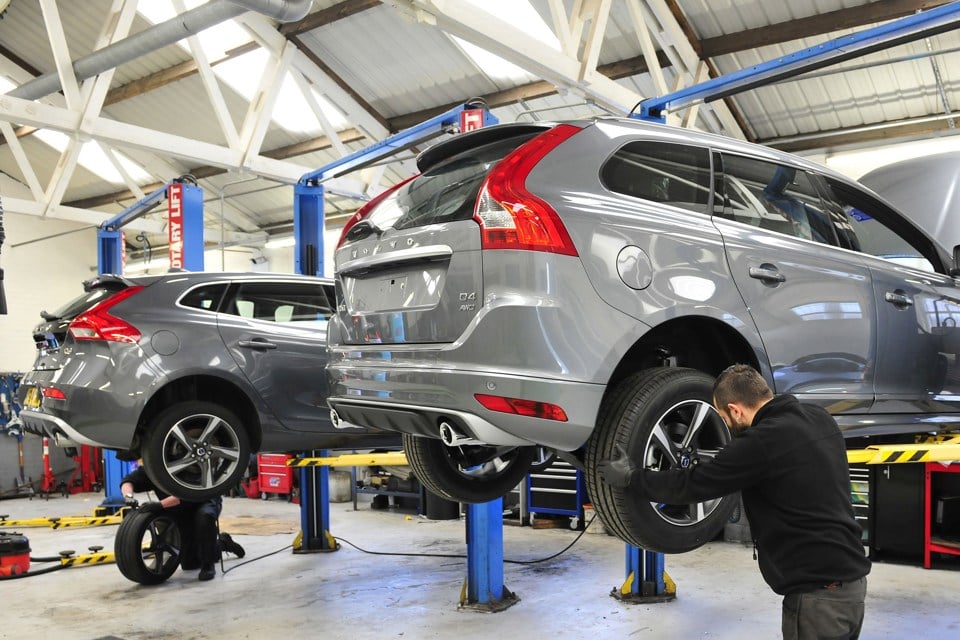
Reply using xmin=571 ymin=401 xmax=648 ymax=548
xmin=632 ymin=2 xmax=960 ymax=122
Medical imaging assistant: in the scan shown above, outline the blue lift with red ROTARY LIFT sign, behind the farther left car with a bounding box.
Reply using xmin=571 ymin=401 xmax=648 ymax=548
xmin=97 ymin=176 xmax=203 ymax=513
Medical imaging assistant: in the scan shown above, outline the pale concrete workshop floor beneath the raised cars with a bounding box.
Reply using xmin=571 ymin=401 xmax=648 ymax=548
xmin=0 ymin=494 xmax=960 ymax=640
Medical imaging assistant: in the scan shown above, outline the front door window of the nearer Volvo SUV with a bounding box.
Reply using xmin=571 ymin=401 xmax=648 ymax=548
xmin=812 ymin=178 xmax=936 ymax=272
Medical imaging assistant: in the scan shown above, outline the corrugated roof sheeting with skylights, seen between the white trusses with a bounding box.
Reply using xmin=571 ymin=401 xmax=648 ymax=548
xmin=0 ymin=0 xmax=960 ymax=252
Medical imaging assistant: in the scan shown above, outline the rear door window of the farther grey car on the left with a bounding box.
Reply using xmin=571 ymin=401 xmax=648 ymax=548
xmin=223 ymin=282 xmax=333 ymax=326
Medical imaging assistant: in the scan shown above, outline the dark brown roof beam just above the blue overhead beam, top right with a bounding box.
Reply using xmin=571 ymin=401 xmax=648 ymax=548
xmin=700 ymin=0 xmax=951 ymax=58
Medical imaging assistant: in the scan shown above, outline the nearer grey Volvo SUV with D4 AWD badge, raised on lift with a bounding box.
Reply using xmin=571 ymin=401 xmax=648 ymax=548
xmin=328 ymin=119 xmax=960 ymax=552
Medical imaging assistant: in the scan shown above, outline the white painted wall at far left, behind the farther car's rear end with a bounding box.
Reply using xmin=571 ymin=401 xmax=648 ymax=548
xmin=0 ymin=213 xmax=97 ymax=371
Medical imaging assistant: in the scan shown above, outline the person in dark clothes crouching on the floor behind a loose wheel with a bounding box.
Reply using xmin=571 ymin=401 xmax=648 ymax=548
xmin=120 ymin=466 xmax=244 ymax=580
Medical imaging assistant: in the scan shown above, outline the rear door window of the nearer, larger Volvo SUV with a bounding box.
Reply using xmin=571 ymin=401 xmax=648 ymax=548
xmin=722 ymin=155 xmax=838 ymax=245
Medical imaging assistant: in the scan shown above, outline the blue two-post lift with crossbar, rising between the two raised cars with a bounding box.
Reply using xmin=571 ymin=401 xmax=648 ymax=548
xmin=293 ymin=103 xmax=516 ymax=608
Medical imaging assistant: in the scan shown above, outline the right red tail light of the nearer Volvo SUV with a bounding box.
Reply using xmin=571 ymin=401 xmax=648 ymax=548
xmin=474 ymin=124 xmax=581 ymax=256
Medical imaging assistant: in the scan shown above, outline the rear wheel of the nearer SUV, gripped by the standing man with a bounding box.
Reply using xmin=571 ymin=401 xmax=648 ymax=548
xmin=586 ymin=367 xmax=738 ymax=553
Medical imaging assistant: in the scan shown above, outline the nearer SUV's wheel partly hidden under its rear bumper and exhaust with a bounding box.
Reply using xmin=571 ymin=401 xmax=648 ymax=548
xmin=403 ymin=434 xmax=536 ymax=503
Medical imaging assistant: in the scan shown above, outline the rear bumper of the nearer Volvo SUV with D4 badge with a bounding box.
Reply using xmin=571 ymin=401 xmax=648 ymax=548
xmin=327 ymin=360 xmax=604 ymax=451
